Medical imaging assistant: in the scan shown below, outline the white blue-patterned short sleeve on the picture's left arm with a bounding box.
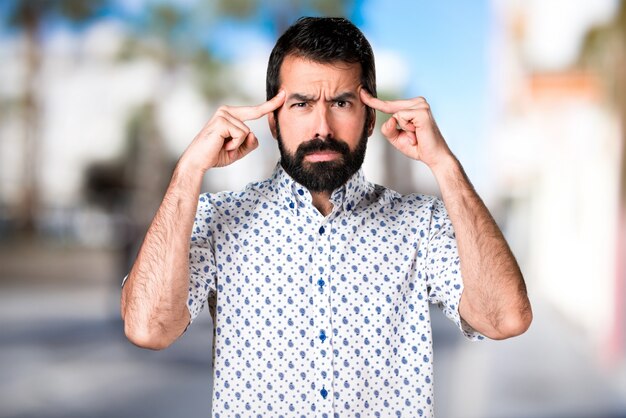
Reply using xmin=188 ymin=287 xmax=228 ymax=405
xmin=187 ymin=194 xmax=217 ymax=322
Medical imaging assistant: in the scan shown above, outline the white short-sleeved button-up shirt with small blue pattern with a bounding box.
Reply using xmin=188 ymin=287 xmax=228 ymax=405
xmin=188 ymin=164 xmax=482 ymax=418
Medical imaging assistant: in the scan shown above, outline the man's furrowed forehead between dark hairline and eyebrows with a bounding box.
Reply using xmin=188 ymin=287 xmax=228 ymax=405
xmin=280 ymin=55 xmax=361 ymax=93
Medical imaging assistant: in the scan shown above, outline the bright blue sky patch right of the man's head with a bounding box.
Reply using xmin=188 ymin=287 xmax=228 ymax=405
xmin=362 ymin=0 xmax=490 ymax=176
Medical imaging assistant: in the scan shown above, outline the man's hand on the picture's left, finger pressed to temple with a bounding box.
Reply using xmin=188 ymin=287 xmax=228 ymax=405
xmin=179 ymin=90 xmax=285 ymax=173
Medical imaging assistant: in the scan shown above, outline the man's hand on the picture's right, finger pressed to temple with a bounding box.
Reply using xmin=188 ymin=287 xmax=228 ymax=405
xmin=360 ymin=89 xmax=452 ymax=169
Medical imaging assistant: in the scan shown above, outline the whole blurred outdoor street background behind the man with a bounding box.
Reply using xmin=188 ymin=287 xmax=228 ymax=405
xmin=0 ymin=0 xmax=626 ymax=418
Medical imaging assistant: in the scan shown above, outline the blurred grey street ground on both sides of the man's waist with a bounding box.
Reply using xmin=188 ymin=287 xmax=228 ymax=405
xmin=0 ymin=245 xmax=626 ymax=418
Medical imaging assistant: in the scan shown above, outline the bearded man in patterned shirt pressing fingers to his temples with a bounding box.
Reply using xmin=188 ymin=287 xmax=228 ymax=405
xmin=122 ymin=18 xmax=532 ymax=417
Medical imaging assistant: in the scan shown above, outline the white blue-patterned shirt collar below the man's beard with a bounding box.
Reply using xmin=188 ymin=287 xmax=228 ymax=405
xmin=266 ymin=162 xmax=374 ymax=214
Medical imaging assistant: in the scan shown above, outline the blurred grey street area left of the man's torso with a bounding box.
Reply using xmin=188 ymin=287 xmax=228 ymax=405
xmin=0 ymin=243 xmax=211 ymax=418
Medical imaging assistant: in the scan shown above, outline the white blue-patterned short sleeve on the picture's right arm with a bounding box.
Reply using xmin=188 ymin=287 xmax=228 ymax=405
xmin=426 ymin=198 xmax=484 ymax=341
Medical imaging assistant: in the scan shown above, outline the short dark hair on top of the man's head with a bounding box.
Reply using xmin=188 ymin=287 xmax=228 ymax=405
xmin=265 ymin=17 xmax=376 ymax=119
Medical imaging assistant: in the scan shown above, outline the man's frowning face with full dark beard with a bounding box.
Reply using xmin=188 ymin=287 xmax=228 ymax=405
xmin=270 ymin=56 xmax=373 ymax=192
